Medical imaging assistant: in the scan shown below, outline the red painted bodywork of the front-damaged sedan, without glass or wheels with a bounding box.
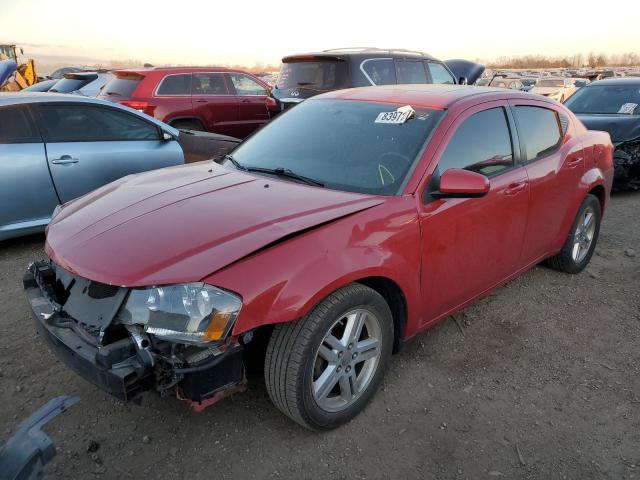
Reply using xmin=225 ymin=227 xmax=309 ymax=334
xmin=46 ymin=86 xmax=613 ymax=339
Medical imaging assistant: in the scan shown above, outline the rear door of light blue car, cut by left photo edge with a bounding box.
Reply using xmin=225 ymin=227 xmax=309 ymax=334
xmin=0 ymin=104 xmax=58 ymax=238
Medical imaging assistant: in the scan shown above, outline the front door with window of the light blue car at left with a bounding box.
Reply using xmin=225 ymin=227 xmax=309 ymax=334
xmin=38 ymin=102 xmax=184 ymax=202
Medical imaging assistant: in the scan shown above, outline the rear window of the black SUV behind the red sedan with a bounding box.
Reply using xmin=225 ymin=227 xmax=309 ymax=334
xmin=276 ymin=60 xmax=348 ymax=90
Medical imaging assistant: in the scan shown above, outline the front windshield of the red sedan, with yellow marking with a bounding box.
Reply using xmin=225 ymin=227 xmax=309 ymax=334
xmin=228 ymin=100 xmax=443 ymax=195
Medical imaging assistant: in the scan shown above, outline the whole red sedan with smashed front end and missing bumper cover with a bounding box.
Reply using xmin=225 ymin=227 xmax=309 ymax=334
xmin=24 ymin=85 xmax=613 ymax=429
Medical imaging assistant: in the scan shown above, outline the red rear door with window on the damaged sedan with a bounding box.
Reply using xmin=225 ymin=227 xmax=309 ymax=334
xmin=510 ymin=100 xmax=584 ymax=263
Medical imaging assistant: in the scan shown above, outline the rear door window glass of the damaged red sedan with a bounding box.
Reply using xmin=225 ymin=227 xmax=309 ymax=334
xmin=515 ymin=105 xmax=562 ymax=162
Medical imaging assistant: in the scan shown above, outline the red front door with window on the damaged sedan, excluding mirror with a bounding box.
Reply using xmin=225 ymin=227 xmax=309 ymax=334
xmin=420 ymin=102 xmax=529 ymax=323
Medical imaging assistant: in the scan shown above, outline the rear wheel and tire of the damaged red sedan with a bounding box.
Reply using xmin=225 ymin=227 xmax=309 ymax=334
xmin=546 ymin=194 xmax=602 ymax=273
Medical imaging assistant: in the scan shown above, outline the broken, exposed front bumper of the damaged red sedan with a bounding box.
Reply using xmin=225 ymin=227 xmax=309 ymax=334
xmin=23 ymin=262 xmax=246 ymax=410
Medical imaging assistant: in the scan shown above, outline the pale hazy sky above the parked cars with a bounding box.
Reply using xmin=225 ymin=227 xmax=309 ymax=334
xmin=0 ymin=0 xmax=640 ymax=70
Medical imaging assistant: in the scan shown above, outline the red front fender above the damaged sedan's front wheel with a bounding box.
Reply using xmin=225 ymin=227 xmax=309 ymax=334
xmin=204 ymin=197 xmax=421 ymax=335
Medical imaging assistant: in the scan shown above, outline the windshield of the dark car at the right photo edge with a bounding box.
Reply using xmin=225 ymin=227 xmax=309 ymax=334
xmin=565 ymin=83 xmax=640 ymax=115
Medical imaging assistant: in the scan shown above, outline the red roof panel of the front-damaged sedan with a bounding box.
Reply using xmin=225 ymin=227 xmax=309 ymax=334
xmin=313 ymin=84 xmax=528 ymax=109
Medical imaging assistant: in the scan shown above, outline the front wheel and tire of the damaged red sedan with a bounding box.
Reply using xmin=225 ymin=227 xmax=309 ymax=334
xmin=265 ymin=283 xmax=393 ymax=430
